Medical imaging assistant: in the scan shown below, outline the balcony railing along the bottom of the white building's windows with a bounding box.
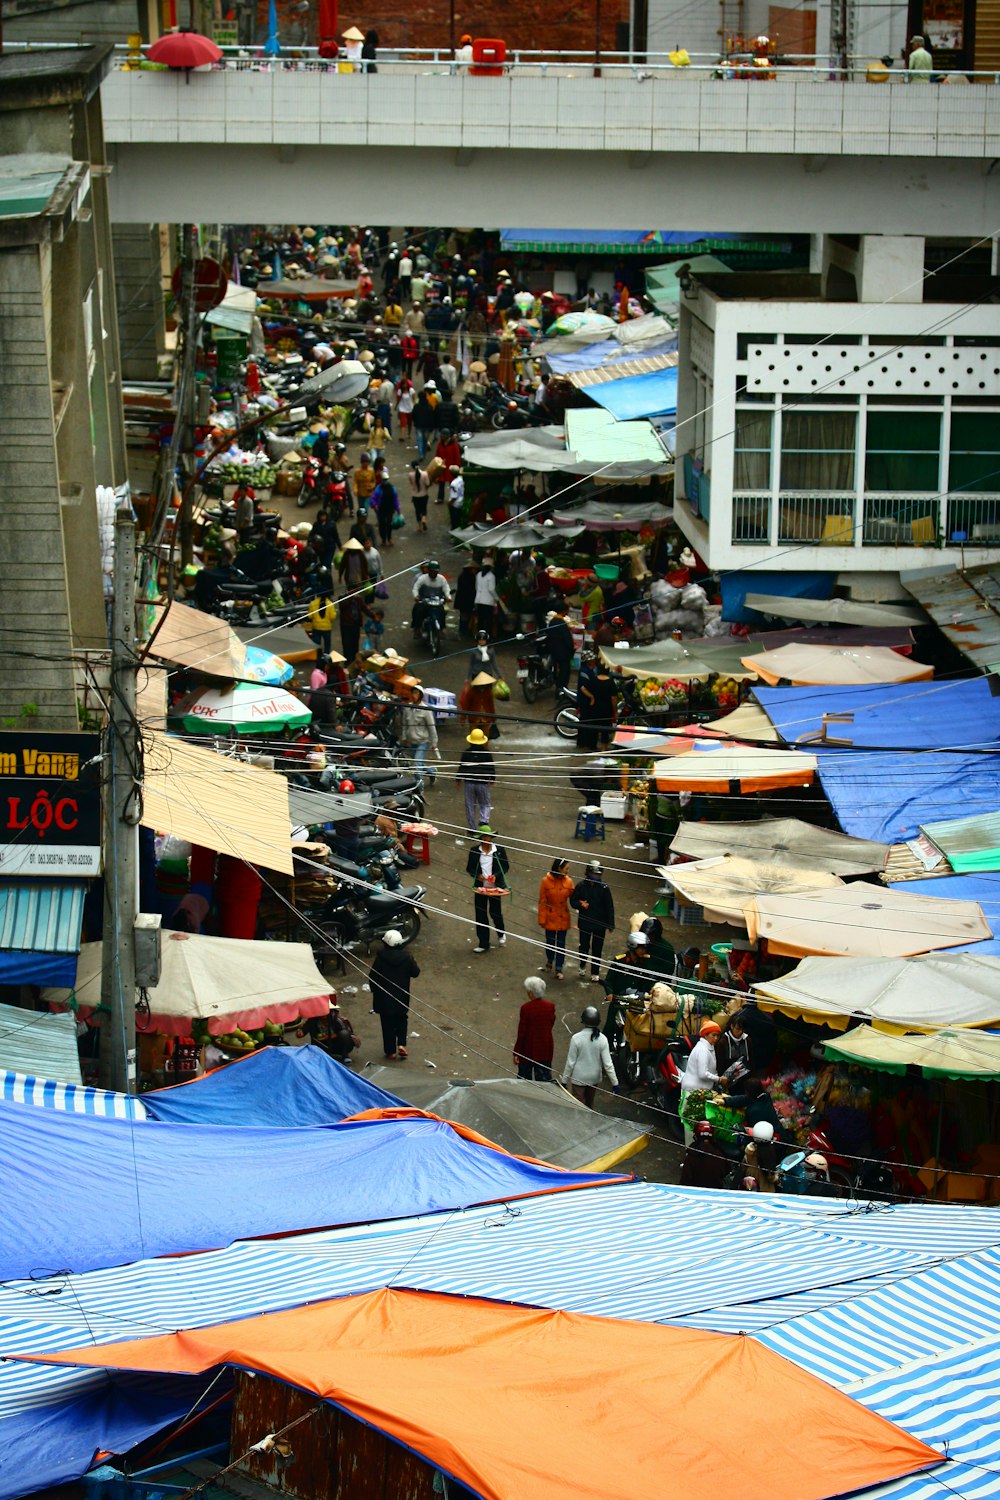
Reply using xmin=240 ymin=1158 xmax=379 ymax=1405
xmin=732 ymin=491 xmax=1000 ymax=548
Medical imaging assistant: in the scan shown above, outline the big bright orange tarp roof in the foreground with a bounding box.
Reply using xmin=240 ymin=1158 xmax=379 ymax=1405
xmin=31 ymin=1290 xmax=942 ymax=1500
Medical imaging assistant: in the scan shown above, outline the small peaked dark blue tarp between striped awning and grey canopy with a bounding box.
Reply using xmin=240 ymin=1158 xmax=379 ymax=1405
xmin=142 ymin=1047 xmax=403 ymax=1125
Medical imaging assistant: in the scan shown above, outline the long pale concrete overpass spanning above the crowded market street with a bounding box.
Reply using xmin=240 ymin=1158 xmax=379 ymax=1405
xmin=102 ymin=60 xmax=1000 ymax=236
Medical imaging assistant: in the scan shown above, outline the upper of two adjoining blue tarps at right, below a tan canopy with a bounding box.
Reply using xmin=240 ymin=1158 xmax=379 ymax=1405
xmin=754 ymin=677 xmax=1000 ymax=750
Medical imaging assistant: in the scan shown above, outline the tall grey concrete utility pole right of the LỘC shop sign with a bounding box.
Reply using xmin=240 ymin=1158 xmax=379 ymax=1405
xmin=100 ymin=506 xmax=141 ymax=1094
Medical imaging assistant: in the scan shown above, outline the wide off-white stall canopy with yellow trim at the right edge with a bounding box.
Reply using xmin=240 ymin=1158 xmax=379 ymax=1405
xmin=756 ymin=953 xmax=1000 ymax=1032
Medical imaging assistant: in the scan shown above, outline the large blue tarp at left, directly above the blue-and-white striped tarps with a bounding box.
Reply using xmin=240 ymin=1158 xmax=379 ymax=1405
xmin=0 ymin=1103 xmax=612 ymax=1281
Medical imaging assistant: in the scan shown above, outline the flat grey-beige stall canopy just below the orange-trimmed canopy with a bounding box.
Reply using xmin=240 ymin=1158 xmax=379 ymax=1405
xmin=670 ymin=818 xmax=889 ymax=875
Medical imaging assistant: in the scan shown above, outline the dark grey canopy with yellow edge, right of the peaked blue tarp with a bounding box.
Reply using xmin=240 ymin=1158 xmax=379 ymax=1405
xmin=364 ymin=1068 xmax=649 ymax=1172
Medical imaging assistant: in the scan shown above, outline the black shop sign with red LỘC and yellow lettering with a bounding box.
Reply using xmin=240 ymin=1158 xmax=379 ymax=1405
xmin=0 ymin=734 xmax=102 ymax=879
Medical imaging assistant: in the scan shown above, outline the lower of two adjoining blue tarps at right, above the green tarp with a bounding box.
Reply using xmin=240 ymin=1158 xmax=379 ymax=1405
xmin=815 ymin=750 xmax=1000 ymax=843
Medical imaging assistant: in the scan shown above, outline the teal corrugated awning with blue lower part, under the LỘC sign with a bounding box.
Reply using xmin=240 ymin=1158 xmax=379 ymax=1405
xmin=0 ymin=881 xmax=87 ymax=996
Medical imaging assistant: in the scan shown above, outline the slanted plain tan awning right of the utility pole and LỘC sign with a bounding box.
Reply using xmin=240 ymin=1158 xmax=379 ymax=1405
xmin=142 ymin=735 xmax=292 ymax=875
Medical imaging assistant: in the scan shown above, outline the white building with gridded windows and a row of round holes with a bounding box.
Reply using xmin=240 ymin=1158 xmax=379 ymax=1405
xmin=675 ymin=242 xmax=1000 ymax=575
